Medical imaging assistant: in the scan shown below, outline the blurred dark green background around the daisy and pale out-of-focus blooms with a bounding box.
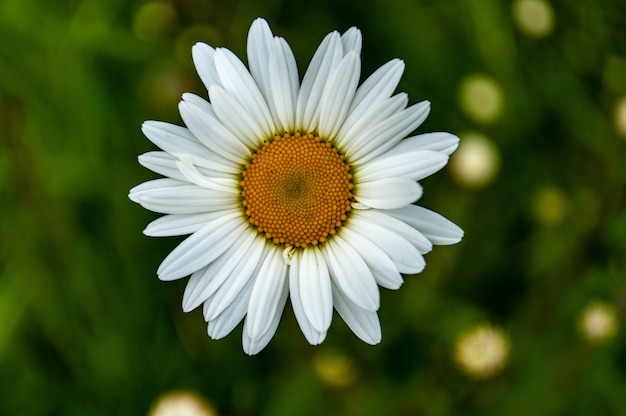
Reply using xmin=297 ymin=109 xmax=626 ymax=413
xmin=0 ymin=0 xmax=626 ymax=415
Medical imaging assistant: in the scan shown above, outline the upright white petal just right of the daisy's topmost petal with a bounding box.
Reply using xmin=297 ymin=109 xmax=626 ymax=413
xmin=269 ymin=38 xmax=300 ymax=132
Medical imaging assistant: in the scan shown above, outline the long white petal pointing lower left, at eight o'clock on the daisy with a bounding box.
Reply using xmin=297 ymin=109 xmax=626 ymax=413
xmin=157 ymin=212 xmax=248 ymax=280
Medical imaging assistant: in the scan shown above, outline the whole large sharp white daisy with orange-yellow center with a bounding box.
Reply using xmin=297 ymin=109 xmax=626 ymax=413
xmin=130 ymin=18 xmax=463 ymax=354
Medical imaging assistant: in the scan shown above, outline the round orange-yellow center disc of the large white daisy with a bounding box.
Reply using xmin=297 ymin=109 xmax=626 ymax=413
xmin=241 ymin=132 xmax=352 ymax=247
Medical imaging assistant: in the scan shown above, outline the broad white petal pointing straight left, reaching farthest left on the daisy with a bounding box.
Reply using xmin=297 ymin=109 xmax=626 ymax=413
xmin=128 ymin=178 xmax=241 ymax=214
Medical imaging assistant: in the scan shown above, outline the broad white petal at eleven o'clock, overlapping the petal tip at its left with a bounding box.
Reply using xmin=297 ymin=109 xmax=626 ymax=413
xmin=209 ymin=48 xmax=276 ymax=137
